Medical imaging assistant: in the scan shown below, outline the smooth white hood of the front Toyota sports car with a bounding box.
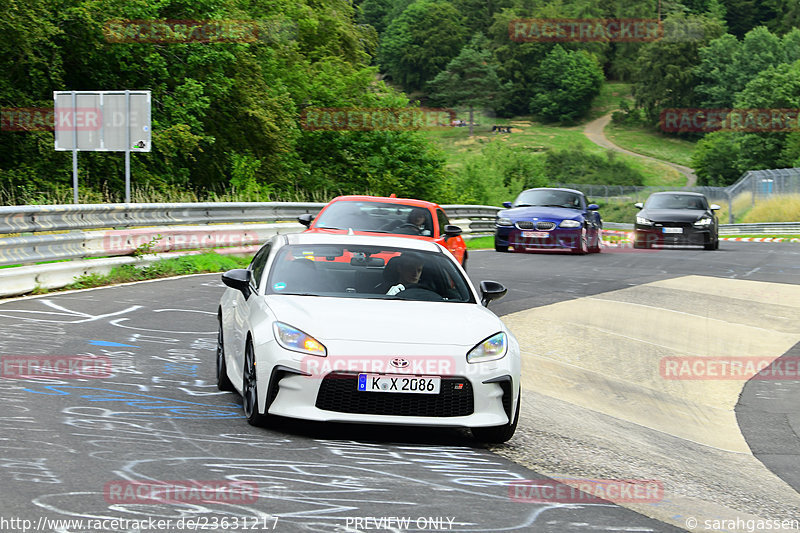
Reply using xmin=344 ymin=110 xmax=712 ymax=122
xmin=265 ymin=295 xmax=504 ymax=348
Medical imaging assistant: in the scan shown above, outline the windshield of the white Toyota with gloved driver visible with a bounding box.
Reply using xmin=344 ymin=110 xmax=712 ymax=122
xmin=266 ymin=244 xmax=475 ymax=303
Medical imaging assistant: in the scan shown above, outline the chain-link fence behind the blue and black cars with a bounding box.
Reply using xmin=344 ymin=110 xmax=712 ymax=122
xmin=555 ymin=168 xmax=800 ymax=224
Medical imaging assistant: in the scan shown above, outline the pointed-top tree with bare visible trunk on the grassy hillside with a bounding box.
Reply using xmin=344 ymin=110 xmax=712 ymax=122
xmin=428 ymin=34 xmax=502 ymax=135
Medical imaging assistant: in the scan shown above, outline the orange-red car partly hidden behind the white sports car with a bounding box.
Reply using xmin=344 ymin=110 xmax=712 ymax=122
xmin=297 ymin=196 xmax=467 ymax=267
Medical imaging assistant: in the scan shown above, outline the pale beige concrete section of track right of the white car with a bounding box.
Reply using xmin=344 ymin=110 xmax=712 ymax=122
xmin=503 ymin=276 xmax=800 ymax=453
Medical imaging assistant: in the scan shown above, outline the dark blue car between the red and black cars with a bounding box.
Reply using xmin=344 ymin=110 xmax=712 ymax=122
xmin=494 ymin=188 xmax=603 ymax=254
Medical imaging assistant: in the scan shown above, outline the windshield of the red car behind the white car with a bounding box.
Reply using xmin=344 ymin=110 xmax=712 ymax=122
xmin=314 ymin=201 xmax=433 ymax=237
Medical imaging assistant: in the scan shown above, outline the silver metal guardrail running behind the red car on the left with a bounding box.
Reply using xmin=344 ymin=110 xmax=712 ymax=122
xmin=0 ymin=206 xmax=500 ymax=265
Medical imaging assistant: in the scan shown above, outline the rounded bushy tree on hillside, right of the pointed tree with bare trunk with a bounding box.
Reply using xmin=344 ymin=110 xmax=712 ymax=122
xmin=530 ymin=45 xmax=603 ymax=123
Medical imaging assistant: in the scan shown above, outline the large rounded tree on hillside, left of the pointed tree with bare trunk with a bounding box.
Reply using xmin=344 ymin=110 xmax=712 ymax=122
xmin=378 ymin=0 xmax=467 ymax=91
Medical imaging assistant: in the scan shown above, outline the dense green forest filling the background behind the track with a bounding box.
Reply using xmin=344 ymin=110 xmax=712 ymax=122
xmin=0 ymin=0 xmax=800 ymax=202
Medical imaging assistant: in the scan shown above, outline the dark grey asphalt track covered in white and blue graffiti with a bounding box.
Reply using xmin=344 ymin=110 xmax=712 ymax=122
xmin=0 ymin=243 xmax=800 ymax=532
